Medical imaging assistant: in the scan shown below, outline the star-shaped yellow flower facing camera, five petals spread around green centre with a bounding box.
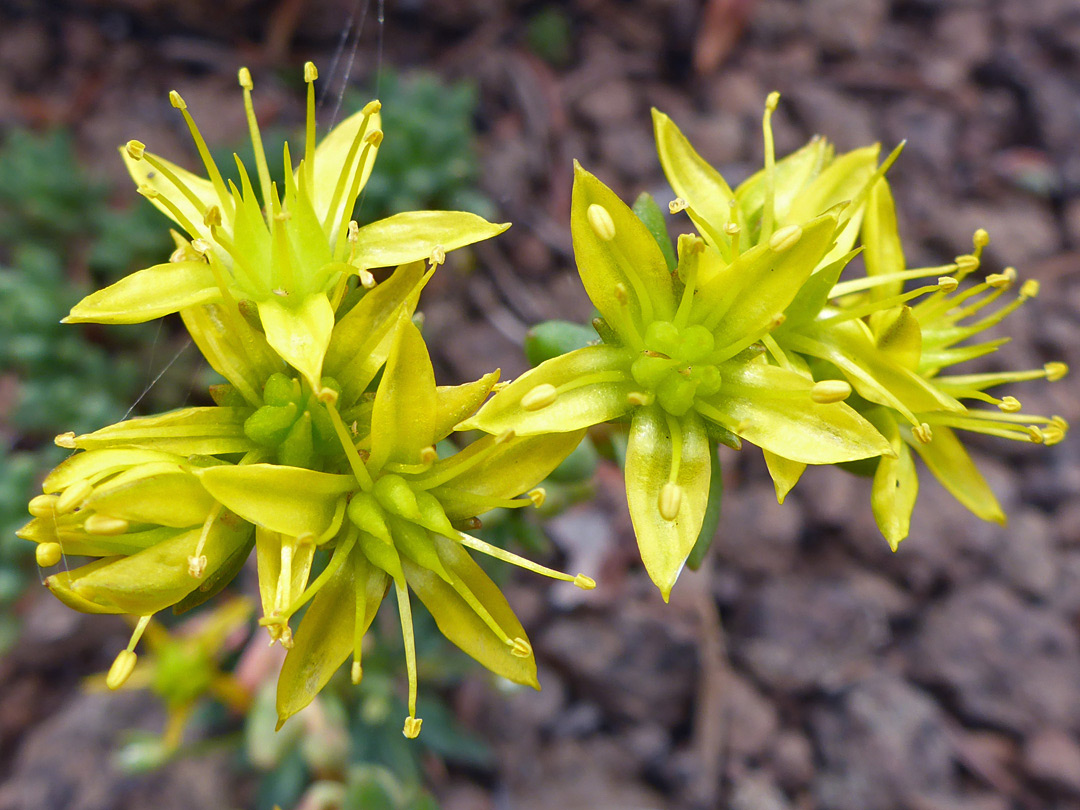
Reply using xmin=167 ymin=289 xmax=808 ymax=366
xmin=460 ymin=166 xmax=891 ymax=599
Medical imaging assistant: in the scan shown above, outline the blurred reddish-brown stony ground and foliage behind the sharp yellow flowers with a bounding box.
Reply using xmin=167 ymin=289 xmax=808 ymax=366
xmin=0 ymin=0 xmax=1080 ymax=810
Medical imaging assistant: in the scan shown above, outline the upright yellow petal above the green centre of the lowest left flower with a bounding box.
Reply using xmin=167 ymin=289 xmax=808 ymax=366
xmin=367 ymin=316 xmax=436 ymax=474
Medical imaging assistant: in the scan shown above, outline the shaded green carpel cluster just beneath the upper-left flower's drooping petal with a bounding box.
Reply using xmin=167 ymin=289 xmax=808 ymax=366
xmin=244 ymin=374 xmax=341 ymax=469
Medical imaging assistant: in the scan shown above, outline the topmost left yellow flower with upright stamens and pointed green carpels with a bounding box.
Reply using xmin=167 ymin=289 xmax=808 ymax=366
xmin=65 ymin=63 xmax=509 ymax=389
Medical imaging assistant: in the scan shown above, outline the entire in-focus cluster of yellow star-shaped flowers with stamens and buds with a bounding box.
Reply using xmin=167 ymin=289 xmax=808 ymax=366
xmin=19 ymin=69 xmax=1067 ymax=738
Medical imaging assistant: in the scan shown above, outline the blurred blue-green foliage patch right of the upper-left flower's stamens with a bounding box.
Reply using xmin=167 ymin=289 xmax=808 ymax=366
xmin=346 ymin=70 xmax=495 ymax=221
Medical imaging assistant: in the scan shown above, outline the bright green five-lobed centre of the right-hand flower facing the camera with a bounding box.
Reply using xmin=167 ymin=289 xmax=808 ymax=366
xmin=630 ymin=321 xmax=720 ymax=416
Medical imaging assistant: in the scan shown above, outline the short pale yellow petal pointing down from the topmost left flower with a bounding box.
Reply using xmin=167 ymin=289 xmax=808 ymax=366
xmin=258 ymin=293 xmax=334 ymax=391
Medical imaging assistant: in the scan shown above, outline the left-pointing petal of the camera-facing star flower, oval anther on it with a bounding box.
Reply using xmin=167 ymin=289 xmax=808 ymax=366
xmin=459 ymin=346 xmax=640 ymax=435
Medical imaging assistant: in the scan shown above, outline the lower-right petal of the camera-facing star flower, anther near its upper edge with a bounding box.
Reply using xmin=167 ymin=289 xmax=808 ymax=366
xmin=694 ymin=361 xmax=890 ymax=464
